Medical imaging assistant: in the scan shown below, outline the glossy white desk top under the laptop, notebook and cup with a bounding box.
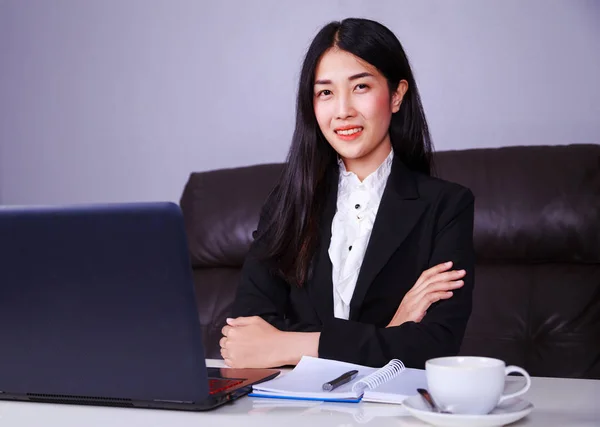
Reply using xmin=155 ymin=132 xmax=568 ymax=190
xmin=0 ymin=360 xmax=600 ymax=427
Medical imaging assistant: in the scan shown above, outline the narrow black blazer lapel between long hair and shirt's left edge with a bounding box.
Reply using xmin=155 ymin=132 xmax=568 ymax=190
xmin=308 ymin=164 xmax=339 ymax=323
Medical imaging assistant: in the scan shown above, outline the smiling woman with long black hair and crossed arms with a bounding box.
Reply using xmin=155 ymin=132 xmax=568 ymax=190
xmin=220 ymin=19 xmax=474 ymax=368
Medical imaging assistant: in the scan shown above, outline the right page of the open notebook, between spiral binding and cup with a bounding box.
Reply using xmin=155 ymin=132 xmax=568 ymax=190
xmin=363 ymin=368 xmax=427 ymax=403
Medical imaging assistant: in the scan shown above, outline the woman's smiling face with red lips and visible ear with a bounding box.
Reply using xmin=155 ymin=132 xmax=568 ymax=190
xmin=313 ymin=48 xmax=408 ymax=180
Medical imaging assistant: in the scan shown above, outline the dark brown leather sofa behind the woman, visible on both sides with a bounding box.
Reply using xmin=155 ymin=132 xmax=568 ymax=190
xmin=181 ymin=145 xmax=600 ymax=379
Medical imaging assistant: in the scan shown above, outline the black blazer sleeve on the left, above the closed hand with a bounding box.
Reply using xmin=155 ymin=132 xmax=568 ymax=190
xmin=232 ymin=195 xmax=319 ymax=332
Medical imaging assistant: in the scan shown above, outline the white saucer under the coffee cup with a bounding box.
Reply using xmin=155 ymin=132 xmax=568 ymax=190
xmin=402 ymin=394 xmax=533 ymax=427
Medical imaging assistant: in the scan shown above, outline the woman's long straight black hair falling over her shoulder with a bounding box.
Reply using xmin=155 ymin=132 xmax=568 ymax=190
xmin=257 ymin=18 xmax=432 ymax=286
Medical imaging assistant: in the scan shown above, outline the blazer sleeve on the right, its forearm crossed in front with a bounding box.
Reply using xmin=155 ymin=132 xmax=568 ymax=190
xmin=319 ymin=186 xmax=475 ymax=368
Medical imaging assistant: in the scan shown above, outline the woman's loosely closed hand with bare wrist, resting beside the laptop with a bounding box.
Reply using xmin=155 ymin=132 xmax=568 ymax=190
xmin=219 ymin=316 xmax=320 ymax=368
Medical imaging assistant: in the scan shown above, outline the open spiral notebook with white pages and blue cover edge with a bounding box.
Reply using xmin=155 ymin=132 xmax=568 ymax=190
xmin=251 ymin=356 xmax=427 ymax=403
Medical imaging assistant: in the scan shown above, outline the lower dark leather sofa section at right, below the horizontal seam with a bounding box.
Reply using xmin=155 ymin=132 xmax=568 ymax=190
xmin=461 ymin=263 xmax=600 ymax=378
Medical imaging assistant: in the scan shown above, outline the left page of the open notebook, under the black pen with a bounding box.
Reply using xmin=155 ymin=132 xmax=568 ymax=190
xmin=252 ymin=356 xmax=377 ymax=399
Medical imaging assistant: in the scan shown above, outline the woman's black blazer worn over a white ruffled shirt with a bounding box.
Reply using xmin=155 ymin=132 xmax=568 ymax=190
xmin=233 ymin=157 xmax=475 ymax=368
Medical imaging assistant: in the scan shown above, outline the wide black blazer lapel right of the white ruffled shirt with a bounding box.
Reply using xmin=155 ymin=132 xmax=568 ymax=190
xmin=350 ymin=157 xmax=427 ymax=320
